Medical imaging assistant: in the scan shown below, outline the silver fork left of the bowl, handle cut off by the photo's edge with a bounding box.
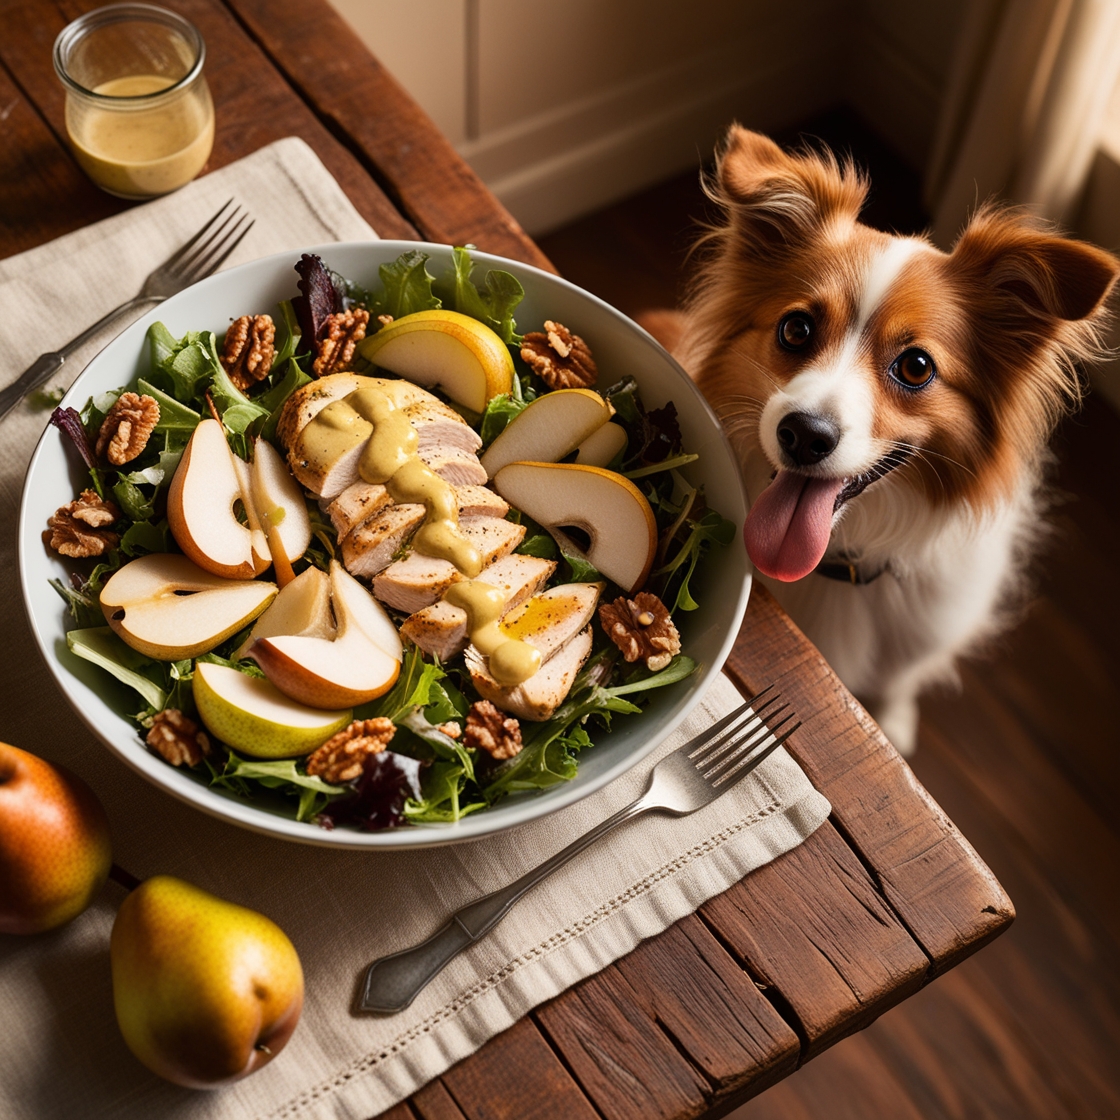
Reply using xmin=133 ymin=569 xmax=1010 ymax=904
xmin=0 ymin=198 xmax=253 ymax=419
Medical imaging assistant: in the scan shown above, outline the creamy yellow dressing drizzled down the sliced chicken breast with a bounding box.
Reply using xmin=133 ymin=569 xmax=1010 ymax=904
xmin=301 ymin=385 xmax=541 ymax=685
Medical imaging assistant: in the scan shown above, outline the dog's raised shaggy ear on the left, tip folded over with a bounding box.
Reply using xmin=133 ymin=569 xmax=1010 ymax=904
xmin=715 ymin=124 xmax=867 ymax=250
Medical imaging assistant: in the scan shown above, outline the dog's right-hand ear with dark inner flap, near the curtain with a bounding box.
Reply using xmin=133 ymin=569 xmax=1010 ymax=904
xmin=952 ymin=206 xmax=1120 ymax=323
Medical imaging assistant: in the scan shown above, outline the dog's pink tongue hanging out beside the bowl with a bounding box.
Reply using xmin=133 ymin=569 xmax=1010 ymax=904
xmin=743 ymin=470 xmax=843 ymax=584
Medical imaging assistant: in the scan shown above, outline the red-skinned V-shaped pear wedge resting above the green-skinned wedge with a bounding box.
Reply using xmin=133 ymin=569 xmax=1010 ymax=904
xmin=249 ymin=560 xmax=403 ymax=708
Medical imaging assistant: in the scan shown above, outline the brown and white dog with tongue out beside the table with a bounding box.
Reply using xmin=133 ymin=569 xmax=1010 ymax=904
xmin=658 ymin=127 xmax=1118 ymax=753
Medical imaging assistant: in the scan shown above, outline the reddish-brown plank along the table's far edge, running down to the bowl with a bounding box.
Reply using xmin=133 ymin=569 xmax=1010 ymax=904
xmin=220 ymin=0 xmax=552 ymax=269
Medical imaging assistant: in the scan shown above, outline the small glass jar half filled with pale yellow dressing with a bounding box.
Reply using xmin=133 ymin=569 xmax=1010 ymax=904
xmin=55 ymin=3 xmax=214 ymax=198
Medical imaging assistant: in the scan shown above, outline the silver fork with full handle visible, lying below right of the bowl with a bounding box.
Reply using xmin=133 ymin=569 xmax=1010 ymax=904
xmin=358 ymin=684 xmax=801 ymax=1012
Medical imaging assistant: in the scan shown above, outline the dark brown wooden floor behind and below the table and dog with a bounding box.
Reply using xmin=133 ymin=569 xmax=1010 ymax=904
xmin=540 ymin=106 xmax=1120 ymax=1120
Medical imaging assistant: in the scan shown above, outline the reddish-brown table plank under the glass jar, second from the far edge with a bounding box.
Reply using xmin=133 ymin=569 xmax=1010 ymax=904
xmin=0 ymin=0 xmax=417 ymax=248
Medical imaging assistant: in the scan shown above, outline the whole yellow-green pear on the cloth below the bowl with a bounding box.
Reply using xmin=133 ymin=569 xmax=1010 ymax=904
xmin=110 ymin=875 xmax=304 ymax=1089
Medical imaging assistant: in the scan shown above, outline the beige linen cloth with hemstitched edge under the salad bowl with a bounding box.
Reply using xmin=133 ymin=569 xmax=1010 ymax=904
xmin=0 ymin=140 xmax=829 ymax=1120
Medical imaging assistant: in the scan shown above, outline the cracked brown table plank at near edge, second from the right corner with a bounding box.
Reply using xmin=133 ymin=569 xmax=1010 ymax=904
xmin=700 ymin=823 xmax=928 ymax=1061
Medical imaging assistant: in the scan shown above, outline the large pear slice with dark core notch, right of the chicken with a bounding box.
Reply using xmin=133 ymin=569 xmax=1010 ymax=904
xmin=494 ymin=463 xmax=657 ymax=592
